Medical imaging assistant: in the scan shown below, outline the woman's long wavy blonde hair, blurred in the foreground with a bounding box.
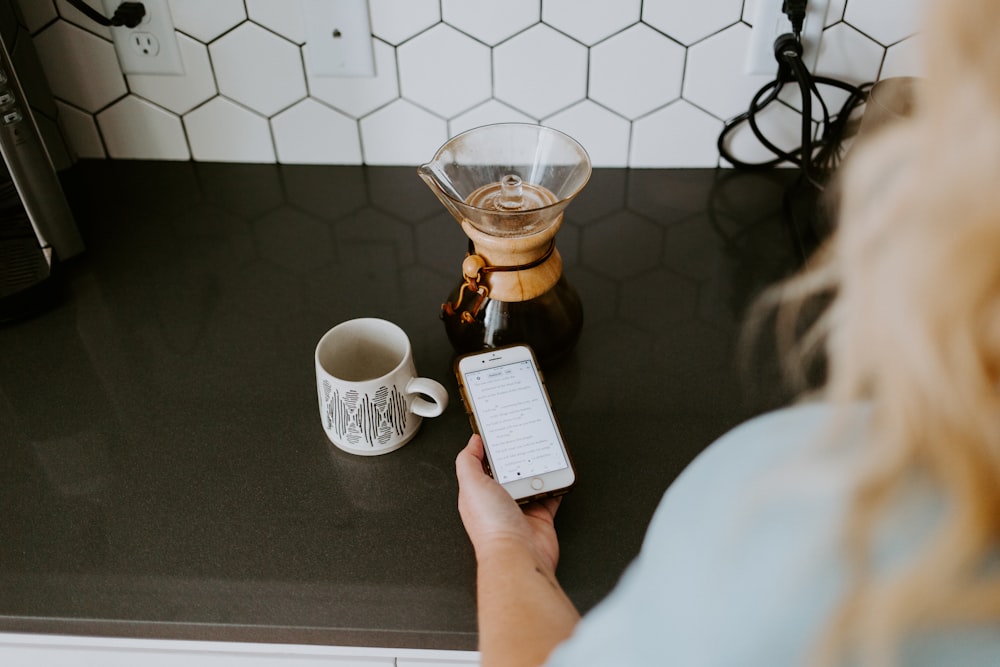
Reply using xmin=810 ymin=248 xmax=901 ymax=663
xmin=756 ymin=0 xmax=1000 ymax=664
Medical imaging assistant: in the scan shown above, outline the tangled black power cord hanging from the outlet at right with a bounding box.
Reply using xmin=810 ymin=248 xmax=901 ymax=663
xmin=717 ymin=0 xmax=873 ymax=261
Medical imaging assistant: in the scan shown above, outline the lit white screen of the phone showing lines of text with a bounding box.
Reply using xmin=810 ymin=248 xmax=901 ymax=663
xmin=465 ymin=360 xmax=569 ymax=484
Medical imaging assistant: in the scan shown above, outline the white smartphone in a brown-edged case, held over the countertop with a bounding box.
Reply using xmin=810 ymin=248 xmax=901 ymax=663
xmin=455 ymin=345 xmax=576 ymax=504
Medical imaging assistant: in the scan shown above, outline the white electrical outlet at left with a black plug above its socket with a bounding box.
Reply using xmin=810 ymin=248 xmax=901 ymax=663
xmin=103 ymin=0 xmax=184 ymax=74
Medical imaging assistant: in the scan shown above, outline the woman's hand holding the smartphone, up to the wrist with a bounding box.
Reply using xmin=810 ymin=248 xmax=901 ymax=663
xmin=455 ymin=434 xmax=562 ymax=572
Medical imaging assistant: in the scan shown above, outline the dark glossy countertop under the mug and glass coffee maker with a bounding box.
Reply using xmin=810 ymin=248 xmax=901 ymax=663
xmin=0 ymin=161 xmax=794 ymax=649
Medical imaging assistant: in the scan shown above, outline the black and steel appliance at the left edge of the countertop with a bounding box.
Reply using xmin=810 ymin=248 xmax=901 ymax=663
xmin=0 ymin=30 xmax=83 ymax=323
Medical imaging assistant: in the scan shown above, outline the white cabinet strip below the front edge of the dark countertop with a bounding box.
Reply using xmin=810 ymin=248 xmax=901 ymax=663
xmin=0 ymin=633 xmax=479 ymax=667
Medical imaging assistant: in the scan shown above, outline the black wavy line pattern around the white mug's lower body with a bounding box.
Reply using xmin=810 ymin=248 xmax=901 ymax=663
xmin=323 ymin=381 xmax=410 ymax=447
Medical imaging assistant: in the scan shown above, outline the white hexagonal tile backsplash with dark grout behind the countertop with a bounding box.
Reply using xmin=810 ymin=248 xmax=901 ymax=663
xmin=17 ymin=0 xmax=920 ymax=168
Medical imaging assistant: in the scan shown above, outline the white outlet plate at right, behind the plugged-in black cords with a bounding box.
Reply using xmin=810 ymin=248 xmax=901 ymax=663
xmin=746 ymin=0 xmax=830 ymax=74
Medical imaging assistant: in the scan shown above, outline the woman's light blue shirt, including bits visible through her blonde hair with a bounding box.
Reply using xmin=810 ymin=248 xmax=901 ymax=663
xmin=548 ymin=403 xmax=1000 ymax=667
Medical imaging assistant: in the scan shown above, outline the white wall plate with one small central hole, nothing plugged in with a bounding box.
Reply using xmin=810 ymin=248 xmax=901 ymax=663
xmin=302 ymin=0 xmax=375 ymax=77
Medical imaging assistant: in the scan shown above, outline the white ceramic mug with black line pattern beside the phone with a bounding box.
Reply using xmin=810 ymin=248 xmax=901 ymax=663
xmin=315 ymin=317 xmax=448 ymax=456
